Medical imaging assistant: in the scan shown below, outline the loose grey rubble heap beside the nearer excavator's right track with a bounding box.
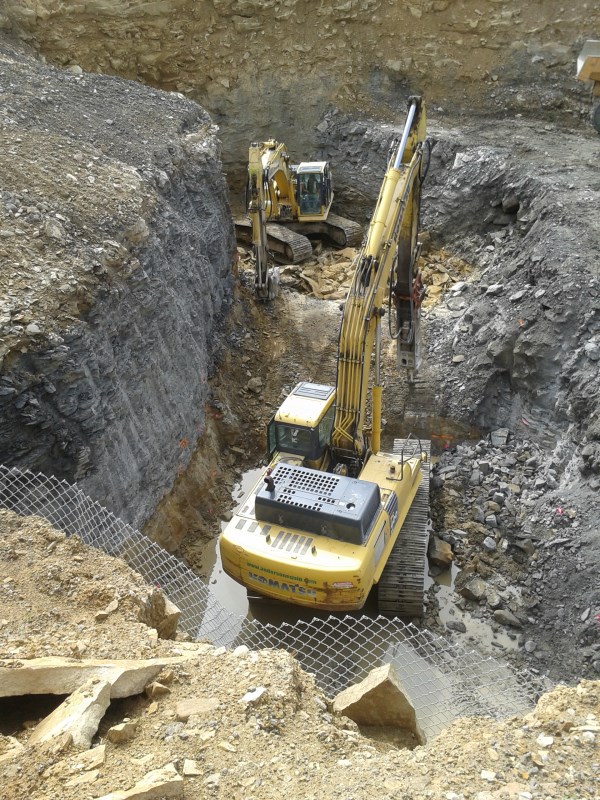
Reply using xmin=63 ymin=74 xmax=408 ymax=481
xmin=428 ymin=429 xmax=600 ymax=679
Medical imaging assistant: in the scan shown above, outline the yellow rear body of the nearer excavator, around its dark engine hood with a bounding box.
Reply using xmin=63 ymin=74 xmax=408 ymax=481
xmin=221 ymin=446 xmax=421 ymax=611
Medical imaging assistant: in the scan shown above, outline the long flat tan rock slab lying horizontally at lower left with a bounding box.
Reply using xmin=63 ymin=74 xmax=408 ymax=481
xmin=0 ymin=656 xmax=188 ymax=699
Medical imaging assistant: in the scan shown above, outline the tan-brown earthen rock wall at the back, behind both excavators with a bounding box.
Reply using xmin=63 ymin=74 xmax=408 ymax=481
xmin=0 ymin=0 xmax=600 ymax=192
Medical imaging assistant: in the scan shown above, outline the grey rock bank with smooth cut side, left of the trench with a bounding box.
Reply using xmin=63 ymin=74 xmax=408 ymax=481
xmin=0 ymin=37 xmax=235 ymax=526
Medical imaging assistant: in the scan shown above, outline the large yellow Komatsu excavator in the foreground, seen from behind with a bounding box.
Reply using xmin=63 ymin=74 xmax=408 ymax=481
xmin=220 ymin=97 xmax=429 ymax=617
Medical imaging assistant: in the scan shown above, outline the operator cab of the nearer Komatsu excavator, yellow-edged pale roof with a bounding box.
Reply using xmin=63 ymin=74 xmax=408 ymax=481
xmin=267 ymin=381 xmax=335 ymax=466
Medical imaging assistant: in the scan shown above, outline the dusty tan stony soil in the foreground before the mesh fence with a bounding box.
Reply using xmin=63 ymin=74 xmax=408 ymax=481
xmin=0 ymin=511 xmax=600 ymax=800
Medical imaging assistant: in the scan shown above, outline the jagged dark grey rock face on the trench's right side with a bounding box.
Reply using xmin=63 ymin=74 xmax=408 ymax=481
xmin=321 ymin=113 xmax=600 ymax=458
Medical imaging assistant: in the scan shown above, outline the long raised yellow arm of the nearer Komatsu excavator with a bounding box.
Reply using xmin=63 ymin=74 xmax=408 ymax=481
xmin=332 ymin=97 xmax=426 ymax=474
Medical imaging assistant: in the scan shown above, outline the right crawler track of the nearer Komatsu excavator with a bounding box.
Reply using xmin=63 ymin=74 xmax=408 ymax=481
xmin=378 ymin=439 xmax=431 ymax=617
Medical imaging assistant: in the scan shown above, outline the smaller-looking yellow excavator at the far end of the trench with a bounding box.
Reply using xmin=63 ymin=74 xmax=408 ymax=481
xmin=235 ymin=140 xmax=362 ymax=300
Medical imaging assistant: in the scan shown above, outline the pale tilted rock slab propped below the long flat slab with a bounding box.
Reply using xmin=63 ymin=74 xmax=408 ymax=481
xmin=28 ymin=678 xmax=111 ymax=749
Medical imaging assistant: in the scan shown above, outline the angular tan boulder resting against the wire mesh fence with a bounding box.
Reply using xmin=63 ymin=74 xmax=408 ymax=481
xmin=333 ymin=664 xmax=425 ymax=744
